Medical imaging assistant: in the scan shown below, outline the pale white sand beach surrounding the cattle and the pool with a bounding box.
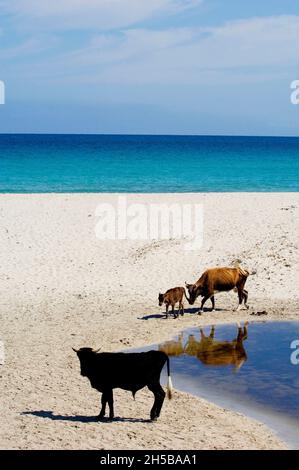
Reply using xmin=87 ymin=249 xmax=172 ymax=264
xmin=0 ymin=193 xmax=299 ymax=449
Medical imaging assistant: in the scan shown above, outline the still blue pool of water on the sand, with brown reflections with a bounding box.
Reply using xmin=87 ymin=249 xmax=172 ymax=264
xmin=135 ymin=322 xmax=299 ymax=449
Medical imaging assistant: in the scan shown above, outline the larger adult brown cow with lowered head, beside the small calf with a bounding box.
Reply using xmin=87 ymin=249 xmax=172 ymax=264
xmin=186 ymin=266 xmax=250 ymax=314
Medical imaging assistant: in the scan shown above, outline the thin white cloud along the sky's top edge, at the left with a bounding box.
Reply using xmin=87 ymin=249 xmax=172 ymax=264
xmin=0 ymin=0 xmax=202 ymax=30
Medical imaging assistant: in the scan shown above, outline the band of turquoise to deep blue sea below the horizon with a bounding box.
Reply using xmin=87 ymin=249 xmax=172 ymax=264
xmin=0 ymin=135 xmax=299 ymax=193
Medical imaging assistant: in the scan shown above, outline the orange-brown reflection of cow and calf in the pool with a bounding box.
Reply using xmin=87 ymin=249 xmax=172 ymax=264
xmin=159 ymin=323 xmax=248 ymax=371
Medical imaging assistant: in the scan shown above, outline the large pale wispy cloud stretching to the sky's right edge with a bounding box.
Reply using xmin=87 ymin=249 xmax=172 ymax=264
xmin=45 ymin=16 xmax=299 ymax=83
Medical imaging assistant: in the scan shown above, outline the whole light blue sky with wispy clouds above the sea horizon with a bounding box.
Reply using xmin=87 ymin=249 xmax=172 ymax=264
xmin=0 ymin=0 xmax=299 ymax=135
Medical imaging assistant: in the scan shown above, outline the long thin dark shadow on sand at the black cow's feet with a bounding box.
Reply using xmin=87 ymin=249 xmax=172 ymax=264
xmin=21 ymin=410 xmax=152 ymax=423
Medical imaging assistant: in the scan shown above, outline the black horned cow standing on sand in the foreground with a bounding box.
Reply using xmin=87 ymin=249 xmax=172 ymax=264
xmin=73 ymin=348 xmax=172 ymax=420
